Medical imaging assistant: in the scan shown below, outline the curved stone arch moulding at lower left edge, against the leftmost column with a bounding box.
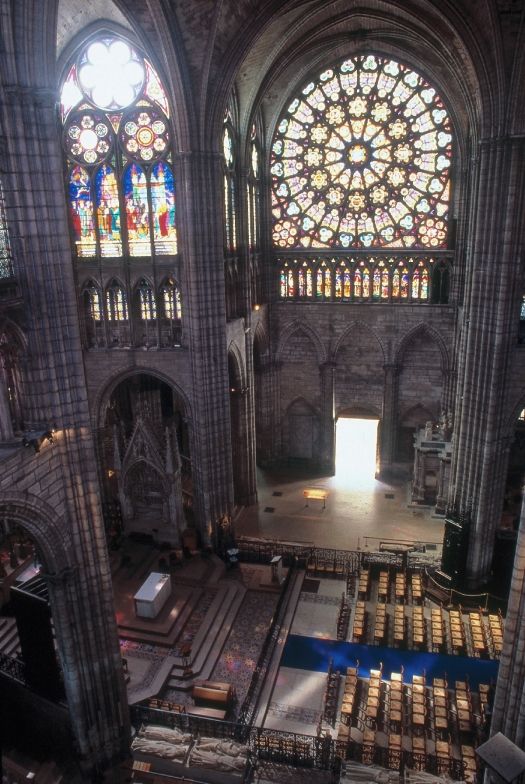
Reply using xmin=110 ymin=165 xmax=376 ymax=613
xmin=0 ymin=493 xmax=70 ymax=575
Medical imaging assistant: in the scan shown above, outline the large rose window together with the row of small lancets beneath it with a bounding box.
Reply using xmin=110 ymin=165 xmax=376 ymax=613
xmin=270 ymin=54 xmax=453 ymax=303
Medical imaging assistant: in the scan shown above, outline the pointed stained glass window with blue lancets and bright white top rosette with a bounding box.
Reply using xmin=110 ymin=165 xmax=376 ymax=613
xmin=61 ymin=35 xmax=177 ymax=258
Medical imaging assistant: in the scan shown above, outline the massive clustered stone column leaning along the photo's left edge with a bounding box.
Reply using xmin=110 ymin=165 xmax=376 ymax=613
xmin=0 ymin=0 xmax=130 ymax=769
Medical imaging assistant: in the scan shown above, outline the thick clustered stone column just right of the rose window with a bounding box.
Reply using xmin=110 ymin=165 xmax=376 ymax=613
xmin=450 ymin=137 xmax=525 ymax=587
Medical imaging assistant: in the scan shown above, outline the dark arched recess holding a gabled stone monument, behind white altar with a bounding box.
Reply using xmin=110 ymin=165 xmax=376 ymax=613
xmin=99 ymin=373 xmax=189 ymax=547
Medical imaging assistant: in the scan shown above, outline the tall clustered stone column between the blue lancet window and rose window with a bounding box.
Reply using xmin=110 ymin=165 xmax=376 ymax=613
xmin=178 ymin=151 xmax=233 ymax=545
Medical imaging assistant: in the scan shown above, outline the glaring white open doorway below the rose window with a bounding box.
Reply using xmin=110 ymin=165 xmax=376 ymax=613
xmin=335 ymin=416 xmax=379 ymax=489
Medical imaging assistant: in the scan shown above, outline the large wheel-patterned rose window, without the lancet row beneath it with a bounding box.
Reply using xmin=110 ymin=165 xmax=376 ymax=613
xmin=271 ymin=55 xmax=452 ymax=249
